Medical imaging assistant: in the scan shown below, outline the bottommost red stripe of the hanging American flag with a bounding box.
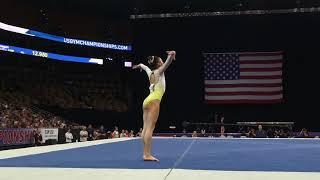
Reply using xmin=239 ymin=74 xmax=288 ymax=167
xmin=205 ymin=99 xmax=283 ymax=104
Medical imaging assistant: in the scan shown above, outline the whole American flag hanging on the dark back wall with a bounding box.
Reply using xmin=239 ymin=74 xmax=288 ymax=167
xmin=203 ymin=52 xmax=283 ymax=104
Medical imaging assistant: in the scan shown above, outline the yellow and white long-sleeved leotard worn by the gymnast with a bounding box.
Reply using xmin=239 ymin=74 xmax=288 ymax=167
xmin=140 ymin=58 xmax=172 ymax=107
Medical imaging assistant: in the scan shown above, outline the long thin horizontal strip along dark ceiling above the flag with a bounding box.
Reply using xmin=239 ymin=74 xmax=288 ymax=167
xmin=130 ymin=7 xmax=320 ymax=19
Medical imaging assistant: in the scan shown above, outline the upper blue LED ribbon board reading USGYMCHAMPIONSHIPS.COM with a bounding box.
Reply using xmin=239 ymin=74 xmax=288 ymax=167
xmin=0 ymin=22 xmax=132 ymax=51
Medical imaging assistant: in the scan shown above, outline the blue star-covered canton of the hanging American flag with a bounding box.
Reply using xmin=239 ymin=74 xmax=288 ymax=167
xmin=204 ymin=53 xmax=240 ymax=80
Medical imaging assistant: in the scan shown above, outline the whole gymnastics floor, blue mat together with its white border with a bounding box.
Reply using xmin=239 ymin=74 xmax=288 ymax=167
xmin=0 ymin=138 xmax=320 ymax=180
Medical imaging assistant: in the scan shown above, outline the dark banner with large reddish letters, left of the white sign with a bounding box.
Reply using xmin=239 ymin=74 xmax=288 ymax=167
xmin=0 ymin=128 xmax=34 ymax=146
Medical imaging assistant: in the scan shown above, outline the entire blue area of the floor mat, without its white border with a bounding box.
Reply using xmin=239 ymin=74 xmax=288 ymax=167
xmin=0 ymin=139 xmax=320 ymax=172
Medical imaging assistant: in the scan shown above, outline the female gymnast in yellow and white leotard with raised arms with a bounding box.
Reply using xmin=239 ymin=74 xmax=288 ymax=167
xmin=133 ymin=51 xmax=176 ymax=161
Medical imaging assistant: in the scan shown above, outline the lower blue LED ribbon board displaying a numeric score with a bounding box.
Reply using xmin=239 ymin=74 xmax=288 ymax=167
xmin=0 ymin=44 xmax=103 ymax=64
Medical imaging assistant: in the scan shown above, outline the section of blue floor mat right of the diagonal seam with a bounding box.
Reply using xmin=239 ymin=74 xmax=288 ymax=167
xmin=177 ymin=140 xmax=320 ymax=172
